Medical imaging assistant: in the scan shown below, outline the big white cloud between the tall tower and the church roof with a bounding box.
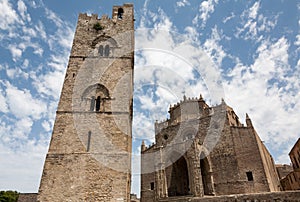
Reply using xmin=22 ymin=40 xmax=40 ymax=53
xmin=133 ymin=7 xmax=224 ymax=148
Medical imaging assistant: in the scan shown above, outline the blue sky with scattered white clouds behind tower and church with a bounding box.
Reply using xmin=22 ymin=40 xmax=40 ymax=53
xmin=0 ymin=0 xmax=300 ymax=197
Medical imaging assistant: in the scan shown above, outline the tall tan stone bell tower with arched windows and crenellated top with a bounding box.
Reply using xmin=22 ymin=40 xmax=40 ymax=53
xmin=38 ymin=4 xmax=134 ymax=202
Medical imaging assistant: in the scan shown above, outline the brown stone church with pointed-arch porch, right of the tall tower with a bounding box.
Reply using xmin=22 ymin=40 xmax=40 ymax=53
xmin=141 ymin=96 xmax=280 ymax=202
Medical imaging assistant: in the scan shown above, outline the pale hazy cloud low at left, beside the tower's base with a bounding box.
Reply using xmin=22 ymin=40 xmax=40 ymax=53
xmin=0 ymin=140 xmax=48 ymax=193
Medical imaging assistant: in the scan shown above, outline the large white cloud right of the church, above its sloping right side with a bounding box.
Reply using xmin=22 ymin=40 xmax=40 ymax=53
xmin=224 ymin=37 xmax=300 ymax=162
